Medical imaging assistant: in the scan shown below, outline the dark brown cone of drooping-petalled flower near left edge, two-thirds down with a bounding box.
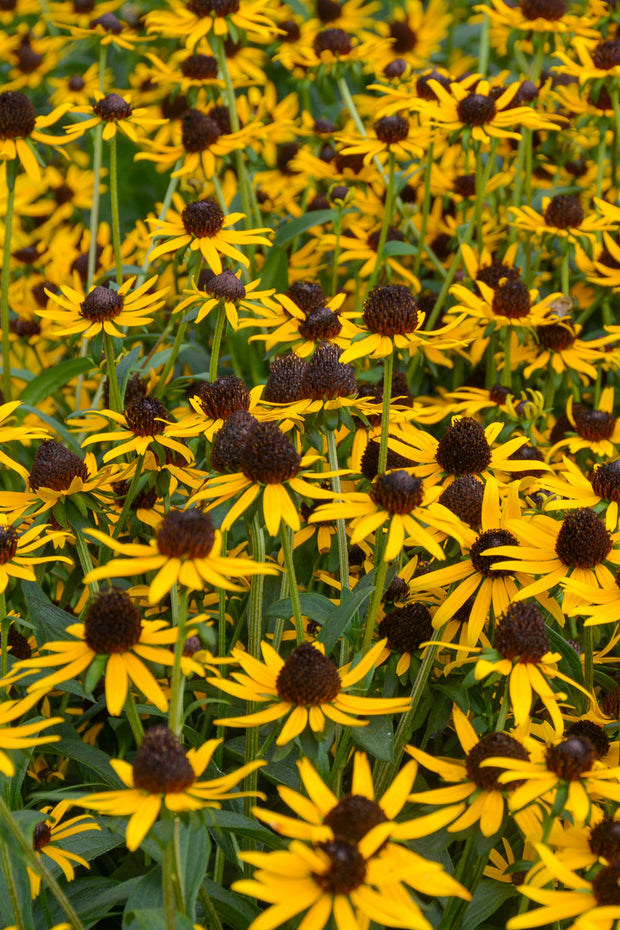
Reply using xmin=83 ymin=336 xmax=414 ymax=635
xmin=84 ymin=588 xmax=142 ymax=655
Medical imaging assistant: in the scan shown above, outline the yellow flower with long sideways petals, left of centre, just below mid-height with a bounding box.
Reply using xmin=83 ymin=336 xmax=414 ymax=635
xmin=85 ymin=508 xmax=277 ymax=604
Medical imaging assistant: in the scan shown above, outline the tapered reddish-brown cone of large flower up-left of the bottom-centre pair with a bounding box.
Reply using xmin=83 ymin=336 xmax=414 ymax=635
xmin=133 ymin=726 xmax=196 ymax=794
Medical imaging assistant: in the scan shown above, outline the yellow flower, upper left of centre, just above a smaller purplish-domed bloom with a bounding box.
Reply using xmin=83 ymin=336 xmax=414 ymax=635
xmin=147 ymin=195 xmax=271 ymax=274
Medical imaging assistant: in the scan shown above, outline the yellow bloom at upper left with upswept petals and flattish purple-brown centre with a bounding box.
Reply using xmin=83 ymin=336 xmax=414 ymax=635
xmin=36 ymin=275 xmax=168 ymax=339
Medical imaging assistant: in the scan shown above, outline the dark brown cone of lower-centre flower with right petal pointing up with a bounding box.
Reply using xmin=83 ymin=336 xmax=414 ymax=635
xmin=276 ymin=643 xmax=342 ymax=707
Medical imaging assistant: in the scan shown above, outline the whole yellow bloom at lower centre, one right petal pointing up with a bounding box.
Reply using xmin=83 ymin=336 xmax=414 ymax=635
xmin=207 ymin=640 xmax=409 ymax=746
